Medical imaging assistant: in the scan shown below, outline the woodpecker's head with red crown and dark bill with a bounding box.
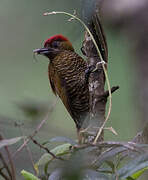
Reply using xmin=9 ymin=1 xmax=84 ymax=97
xmin=33 ymin=34 xmax=74 ymax=59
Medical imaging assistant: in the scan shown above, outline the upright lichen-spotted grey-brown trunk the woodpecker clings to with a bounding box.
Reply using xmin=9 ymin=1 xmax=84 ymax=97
xmin=82 ymin=11 xmax=108 ymax=142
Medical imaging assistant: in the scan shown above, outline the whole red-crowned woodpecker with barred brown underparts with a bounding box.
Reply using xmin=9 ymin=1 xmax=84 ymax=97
xmin=34 ymin=34 xmax=89 ymax=131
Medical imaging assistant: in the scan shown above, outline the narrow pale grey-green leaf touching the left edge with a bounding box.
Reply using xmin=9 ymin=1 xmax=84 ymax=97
xmin=0 ymin=136 xmax=24 ymax=149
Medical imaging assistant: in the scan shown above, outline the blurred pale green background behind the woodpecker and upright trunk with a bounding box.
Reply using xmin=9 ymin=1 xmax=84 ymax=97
xmin=0 ymin=0 xmax=139 ymax=178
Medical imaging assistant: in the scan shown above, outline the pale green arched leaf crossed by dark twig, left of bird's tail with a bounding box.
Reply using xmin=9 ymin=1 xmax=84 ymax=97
xmin=35 ymin=143 xmax=71 ymax=166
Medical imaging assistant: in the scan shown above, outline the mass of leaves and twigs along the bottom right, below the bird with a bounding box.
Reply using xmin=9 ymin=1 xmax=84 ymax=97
xmin=20 ymin=137 xmax=148 ymax=180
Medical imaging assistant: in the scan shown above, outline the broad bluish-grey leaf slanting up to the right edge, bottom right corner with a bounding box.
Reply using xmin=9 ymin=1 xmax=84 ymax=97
xmin=117 ymin=153 xmax=148 ymax=178
